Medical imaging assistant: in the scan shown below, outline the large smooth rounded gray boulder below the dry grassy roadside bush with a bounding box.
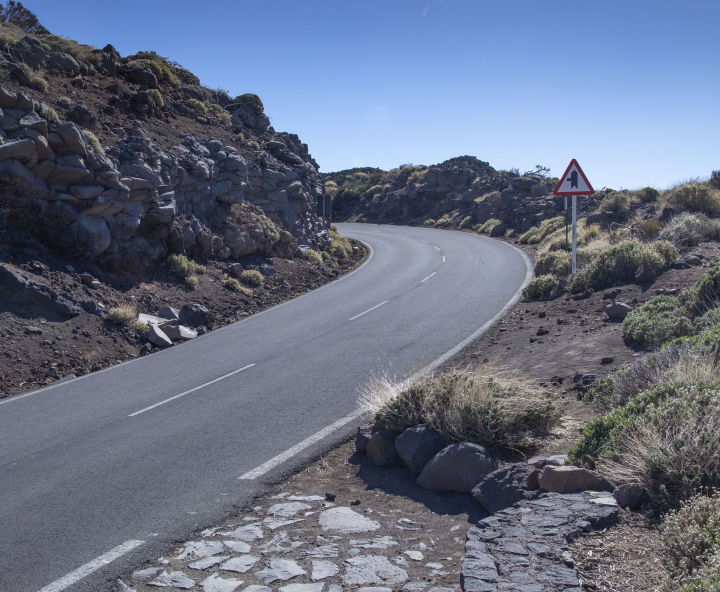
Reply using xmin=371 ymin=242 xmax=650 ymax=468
xmin=417 ymin=442 xmax=493 ymax=493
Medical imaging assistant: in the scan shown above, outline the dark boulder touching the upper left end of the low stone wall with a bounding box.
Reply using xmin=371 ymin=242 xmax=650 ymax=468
xmin=472 ymin=463 xmax=540 ymax=514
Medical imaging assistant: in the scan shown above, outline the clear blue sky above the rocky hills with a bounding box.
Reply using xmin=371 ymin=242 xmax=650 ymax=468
xmin=25 ymin=0 xmax=720 ymax=189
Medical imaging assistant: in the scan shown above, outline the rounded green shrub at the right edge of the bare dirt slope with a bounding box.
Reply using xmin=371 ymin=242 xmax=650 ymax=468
xmin=623 ymin=296 xmax=696 ymax=346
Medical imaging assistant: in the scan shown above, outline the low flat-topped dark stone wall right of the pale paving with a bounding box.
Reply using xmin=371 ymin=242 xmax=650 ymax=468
xmin=462 ymin=491 xmax=619 ymax=592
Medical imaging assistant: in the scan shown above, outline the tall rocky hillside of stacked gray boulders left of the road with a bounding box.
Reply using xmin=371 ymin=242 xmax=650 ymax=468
xmin=0 ymin=23 xmax=331 ymax=274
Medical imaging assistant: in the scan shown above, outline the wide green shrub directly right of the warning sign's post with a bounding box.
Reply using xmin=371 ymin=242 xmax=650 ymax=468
xmin=569 ymin=241 xmax=677 ymax=294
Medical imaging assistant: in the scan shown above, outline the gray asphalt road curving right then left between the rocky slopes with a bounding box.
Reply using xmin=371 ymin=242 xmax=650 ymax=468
xmin=0 ymin=224 xmax=530 ymax=592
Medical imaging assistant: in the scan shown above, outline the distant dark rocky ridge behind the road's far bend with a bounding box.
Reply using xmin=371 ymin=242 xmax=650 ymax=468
xmin=323 ymin=156 xmax=563 ymax=235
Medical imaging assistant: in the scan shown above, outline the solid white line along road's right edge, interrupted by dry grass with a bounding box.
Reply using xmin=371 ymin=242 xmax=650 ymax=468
xmin=238 ymin=234 xmax=534 ymax=479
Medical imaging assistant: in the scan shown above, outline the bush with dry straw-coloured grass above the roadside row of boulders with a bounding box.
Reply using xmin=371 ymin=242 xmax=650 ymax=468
xmin=361 ymin=366 xmax=561 ymax=452
